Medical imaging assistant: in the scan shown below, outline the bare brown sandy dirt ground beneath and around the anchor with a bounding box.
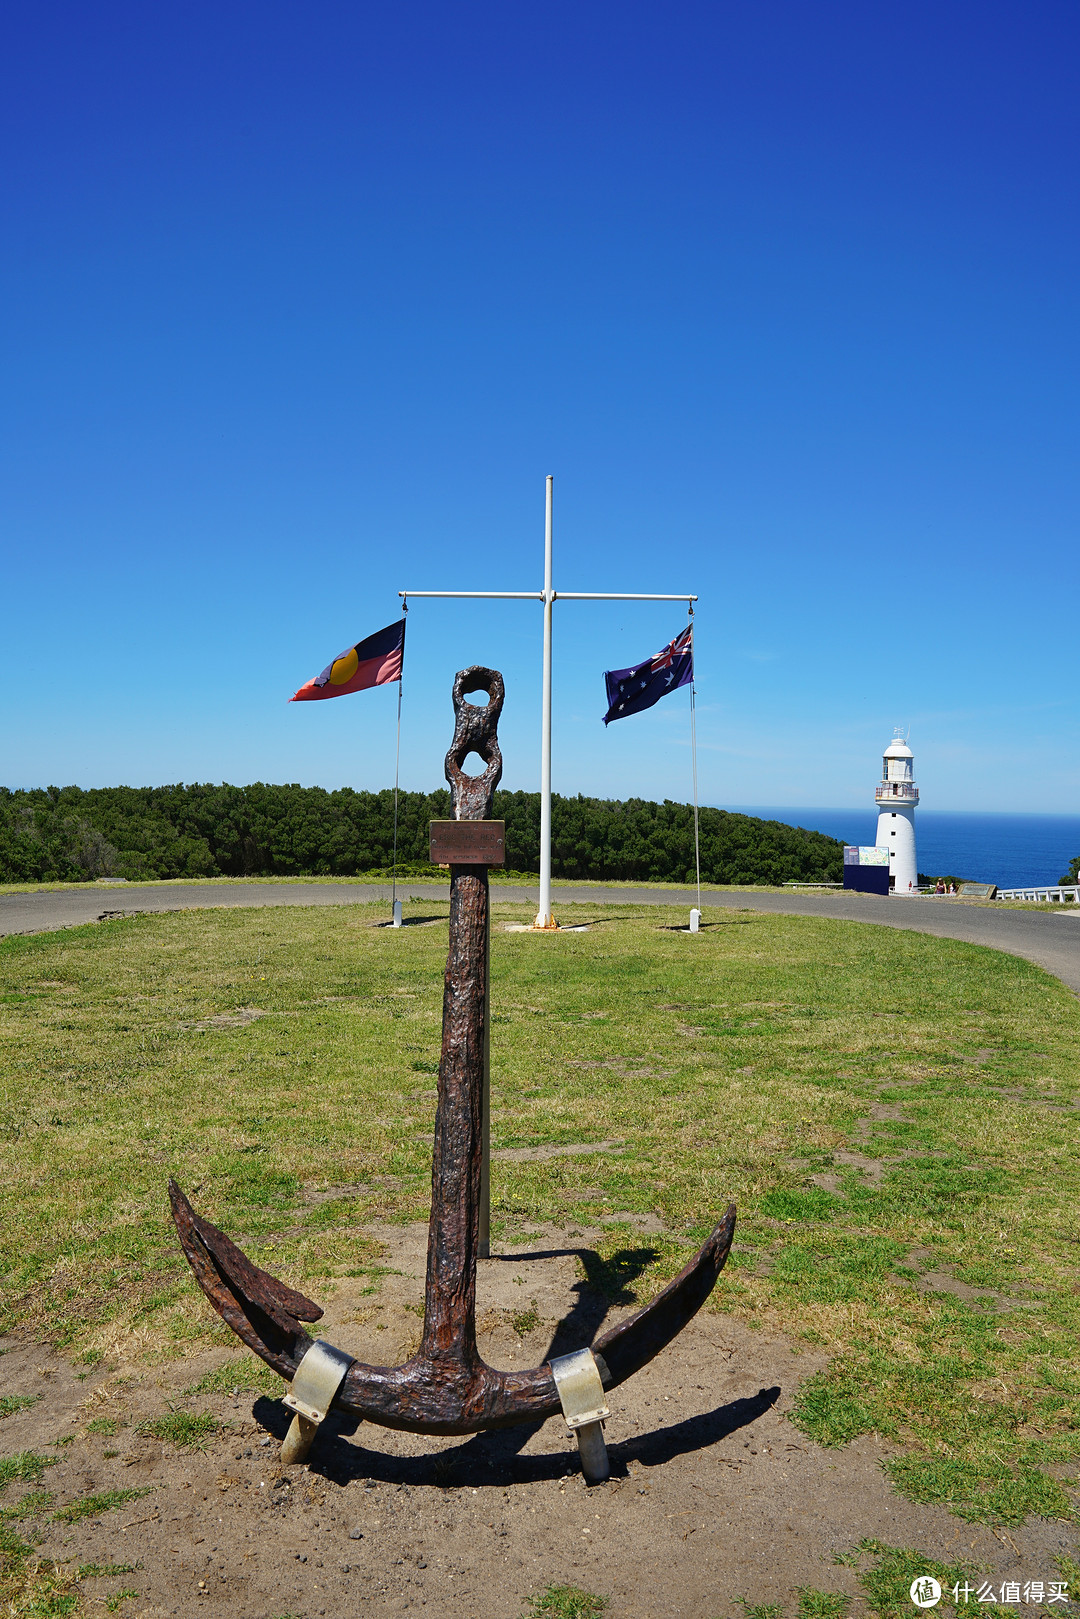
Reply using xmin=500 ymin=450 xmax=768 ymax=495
xmin=0 ymin=1221 xmax=1075 ymax=1619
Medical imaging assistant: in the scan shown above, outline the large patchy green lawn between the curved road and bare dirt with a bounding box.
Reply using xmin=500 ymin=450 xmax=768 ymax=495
xmin=0 ymin=894 xmax=1080 ymax=1523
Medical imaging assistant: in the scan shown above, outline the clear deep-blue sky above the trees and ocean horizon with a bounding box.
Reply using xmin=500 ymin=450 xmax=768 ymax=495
xmin=0 ymin=0 xmax=1080 ymax=811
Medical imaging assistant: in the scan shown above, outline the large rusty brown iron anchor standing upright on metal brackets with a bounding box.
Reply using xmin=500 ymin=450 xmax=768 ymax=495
xmin=168 ymin=665 xmax=735 ymax=1481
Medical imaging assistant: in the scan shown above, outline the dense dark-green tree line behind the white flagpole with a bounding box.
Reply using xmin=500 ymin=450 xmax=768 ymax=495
xmin=0 ymin=782 xmax=844 ymax=884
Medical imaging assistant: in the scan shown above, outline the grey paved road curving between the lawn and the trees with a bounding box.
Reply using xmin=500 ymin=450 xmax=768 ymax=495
xmin=0 ymin=882 xmax=1080 ymax=994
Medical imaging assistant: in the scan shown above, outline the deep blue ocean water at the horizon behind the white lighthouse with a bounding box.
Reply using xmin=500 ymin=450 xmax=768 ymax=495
xmin=724 ymin=805 xmax=1080 ymax=889
